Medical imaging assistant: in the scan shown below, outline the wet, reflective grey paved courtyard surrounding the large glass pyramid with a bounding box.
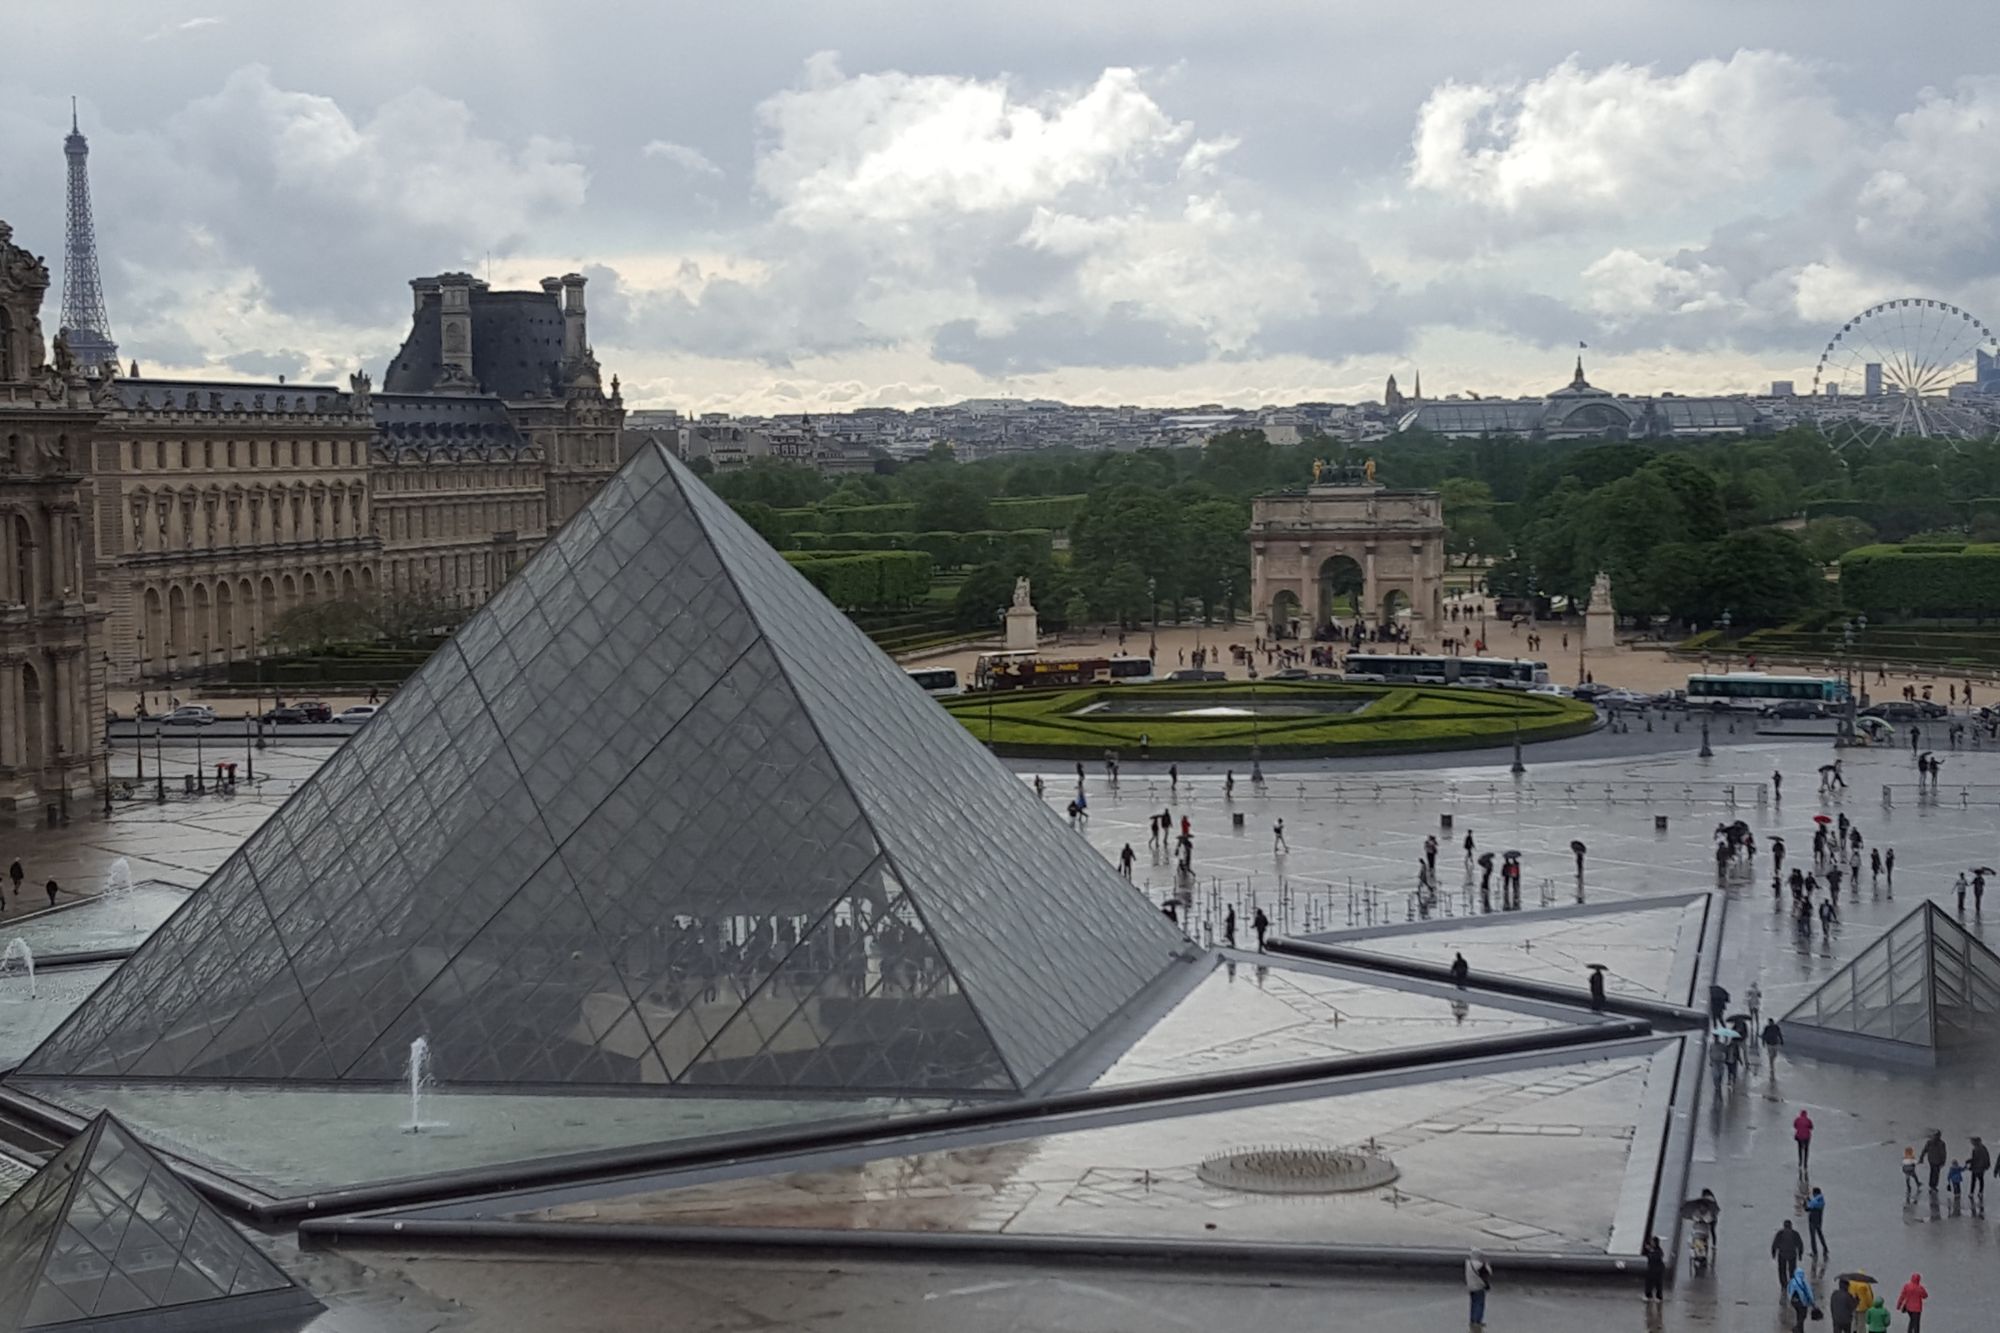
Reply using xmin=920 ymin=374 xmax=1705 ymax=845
xmin=0 ymin=720 xmax=2000 ymax=1333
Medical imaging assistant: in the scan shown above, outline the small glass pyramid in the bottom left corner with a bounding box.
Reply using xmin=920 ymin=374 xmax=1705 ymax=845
xmin=0 ymin=1113 xmax=314 ymax=1333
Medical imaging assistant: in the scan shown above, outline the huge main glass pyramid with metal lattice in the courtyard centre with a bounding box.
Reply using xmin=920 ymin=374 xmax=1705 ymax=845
xmin=16 ymin=444 xmax=1182 ymax=1095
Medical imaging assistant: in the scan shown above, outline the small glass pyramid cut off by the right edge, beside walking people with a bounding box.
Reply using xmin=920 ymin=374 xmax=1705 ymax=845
xmin=1782 ymin=901 xmax=2000 ymax=1047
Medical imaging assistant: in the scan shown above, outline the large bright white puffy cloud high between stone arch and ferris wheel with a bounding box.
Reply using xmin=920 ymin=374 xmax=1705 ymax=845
xmin=1408 ymin=50 xmax=1846 ymax=228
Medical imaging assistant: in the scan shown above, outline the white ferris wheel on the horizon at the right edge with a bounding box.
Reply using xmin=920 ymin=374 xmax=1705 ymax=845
xmin=1812 ymin=296 xmax=2000 ymax=446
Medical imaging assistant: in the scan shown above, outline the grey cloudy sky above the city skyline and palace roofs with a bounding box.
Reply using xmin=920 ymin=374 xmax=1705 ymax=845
xmin=0 ymin=0 xmax=2000 ymax=410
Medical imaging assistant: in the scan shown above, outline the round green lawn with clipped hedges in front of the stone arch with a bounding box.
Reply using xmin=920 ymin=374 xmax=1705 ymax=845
xmin=946 ymin=681 xmax=1596 ymax=759
